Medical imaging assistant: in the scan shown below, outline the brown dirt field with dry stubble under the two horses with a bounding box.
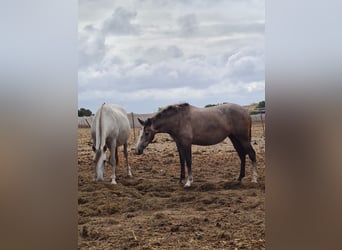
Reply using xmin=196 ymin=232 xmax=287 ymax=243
xmin=78 ymin=123 xmax=265 ymax=250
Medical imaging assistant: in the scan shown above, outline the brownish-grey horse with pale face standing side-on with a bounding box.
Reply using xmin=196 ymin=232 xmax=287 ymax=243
xmin=135 ymin=103 xmax=257 ymax=187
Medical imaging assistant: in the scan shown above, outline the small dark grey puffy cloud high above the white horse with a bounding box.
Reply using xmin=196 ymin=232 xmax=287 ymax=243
xmin=102 ymin=7 xmax=139 ymax=35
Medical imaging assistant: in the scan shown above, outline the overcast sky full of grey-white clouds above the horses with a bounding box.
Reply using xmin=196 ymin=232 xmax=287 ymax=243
xmin=78 ymin=0 xmax=265 ymax=113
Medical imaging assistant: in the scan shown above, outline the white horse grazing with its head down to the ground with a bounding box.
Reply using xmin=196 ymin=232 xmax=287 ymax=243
xmin=91 ymin=103 xmax=132 ymax=184
